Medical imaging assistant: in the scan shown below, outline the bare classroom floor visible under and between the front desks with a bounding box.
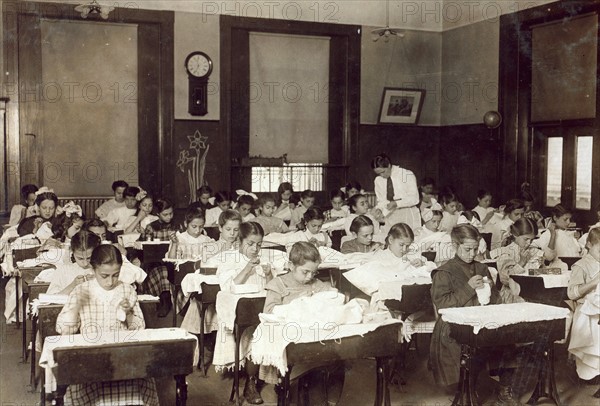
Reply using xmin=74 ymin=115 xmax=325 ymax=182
xmin=0 ymin=284 xmax=600 ymax=406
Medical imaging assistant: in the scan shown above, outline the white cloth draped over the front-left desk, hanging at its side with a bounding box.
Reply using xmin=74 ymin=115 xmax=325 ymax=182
xmin=39 ymin=328 xmax=198 ymax=393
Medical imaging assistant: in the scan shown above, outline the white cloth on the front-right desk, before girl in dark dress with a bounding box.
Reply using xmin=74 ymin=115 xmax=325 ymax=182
xmin=438 ymin=303 xmax=570 ymax=334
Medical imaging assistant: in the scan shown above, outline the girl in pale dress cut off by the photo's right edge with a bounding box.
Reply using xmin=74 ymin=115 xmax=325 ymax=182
xmin=567 ymin=228 xmax=600 ymax=382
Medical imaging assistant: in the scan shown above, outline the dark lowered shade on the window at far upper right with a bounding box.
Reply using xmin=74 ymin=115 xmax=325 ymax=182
xmin=531 ymin=14 xmax=598 ymax=122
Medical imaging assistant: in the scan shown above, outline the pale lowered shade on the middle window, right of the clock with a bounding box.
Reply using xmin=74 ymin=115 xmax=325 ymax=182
xmin=249 ymin=33 xmax=329 ymax=163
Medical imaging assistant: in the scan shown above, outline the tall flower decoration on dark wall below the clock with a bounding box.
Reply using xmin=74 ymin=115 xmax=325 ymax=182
xmin=177 ymin=130 xmax=210 ymax=203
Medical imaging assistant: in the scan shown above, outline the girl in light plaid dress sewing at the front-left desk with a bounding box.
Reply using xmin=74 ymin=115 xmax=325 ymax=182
xmin=56 ymin=245 xmax=159 ymax=406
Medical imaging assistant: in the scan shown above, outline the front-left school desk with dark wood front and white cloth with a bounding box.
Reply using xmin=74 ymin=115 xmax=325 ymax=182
xmin=40 ymin=328 xmax=196 ymax=406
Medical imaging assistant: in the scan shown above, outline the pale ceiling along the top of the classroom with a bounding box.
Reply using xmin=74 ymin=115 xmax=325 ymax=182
xmin=29 ymin=0 xmax=555 ymax=31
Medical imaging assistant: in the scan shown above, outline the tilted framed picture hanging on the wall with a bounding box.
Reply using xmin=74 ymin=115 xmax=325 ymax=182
xmin=378 ymin=87 xmax=425 ymax=125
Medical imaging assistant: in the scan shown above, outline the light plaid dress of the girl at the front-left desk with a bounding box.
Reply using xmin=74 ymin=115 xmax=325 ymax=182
xmin=56 ymin=279 xmax=159 ymax=406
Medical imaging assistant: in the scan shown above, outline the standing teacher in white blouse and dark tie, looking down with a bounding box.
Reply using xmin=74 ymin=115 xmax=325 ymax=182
xmin=371 ymin=154 xmax=421 ymax=230
